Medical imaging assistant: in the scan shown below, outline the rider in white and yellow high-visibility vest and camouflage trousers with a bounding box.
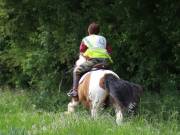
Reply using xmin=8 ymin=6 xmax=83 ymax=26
xmin=67 ymin=22 xmax=112 ymax=97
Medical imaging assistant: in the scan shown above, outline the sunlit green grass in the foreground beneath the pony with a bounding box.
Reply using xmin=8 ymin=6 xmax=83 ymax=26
xmin=0 ymin=90 xmax=180 ymax=135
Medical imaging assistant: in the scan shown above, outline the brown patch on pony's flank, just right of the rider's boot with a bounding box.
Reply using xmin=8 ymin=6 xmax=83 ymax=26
xmin=78 ymin=73 xmax=91 ymax=108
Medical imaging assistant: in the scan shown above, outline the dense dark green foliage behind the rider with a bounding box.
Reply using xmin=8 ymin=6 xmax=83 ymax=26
xmin=0 ymin=0 xmax=180 ymax=94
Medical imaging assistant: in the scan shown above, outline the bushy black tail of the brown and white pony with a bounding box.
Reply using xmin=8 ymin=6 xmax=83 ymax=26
xmin=104 ymin=74 xmax=142 ymax=114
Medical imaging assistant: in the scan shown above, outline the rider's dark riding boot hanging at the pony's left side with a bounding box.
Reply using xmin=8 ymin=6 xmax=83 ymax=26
xmin=68 ymin=72 xmax=81 ymax=97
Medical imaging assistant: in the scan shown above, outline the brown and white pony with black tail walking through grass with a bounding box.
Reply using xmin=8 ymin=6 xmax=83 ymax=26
xmin=67 ymin=55 xmax=143 ymax=125
